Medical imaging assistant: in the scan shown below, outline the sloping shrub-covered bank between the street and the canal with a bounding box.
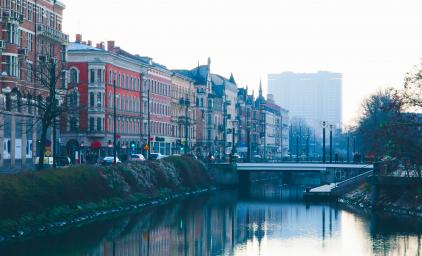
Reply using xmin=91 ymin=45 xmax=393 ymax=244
xmin=0 ymin=157 xmax=211 ymax=237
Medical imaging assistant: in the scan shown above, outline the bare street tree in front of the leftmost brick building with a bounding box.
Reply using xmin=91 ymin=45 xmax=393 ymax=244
xmin=0 ymin=56 xmax=81 ymax=169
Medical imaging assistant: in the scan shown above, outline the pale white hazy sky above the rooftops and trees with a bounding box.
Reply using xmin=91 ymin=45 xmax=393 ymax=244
xmin=63 ymin=0 xmax=422 ymax=125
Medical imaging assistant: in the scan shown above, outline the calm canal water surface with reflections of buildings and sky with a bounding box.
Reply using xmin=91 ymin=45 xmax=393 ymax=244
xmin=0 ymin=182 xmax=422 ymax=256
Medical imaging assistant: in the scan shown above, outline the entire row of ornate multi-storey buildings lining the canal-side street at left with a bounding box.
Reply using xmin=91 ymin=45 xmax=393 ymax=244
xmin=0 ymin=0 xmax=289 ymax=168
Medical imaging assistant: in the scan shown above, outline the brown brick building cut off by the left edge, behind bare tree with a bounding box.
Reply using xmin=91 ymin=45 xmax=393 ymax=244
xmin=0 ymin=0 xmax=68 ymax=169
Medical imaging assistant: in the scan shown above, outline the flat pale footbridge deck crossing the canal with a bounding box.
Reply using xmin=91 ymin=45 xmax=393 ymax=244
xmin=236 ymin=163 xmax=374 ymax=172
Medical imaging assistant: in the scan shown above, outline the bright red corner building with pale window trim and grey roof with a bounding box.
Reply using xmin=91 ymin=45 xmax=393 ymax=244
xmin=61 ymin=35 xmax=144 ymax=160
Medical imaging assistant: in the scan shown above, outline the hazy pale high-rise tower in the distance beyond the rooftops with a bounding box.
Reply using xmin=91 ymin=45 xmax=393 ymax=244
xmin=268 ymin=71 xmax=342 ymax=134
